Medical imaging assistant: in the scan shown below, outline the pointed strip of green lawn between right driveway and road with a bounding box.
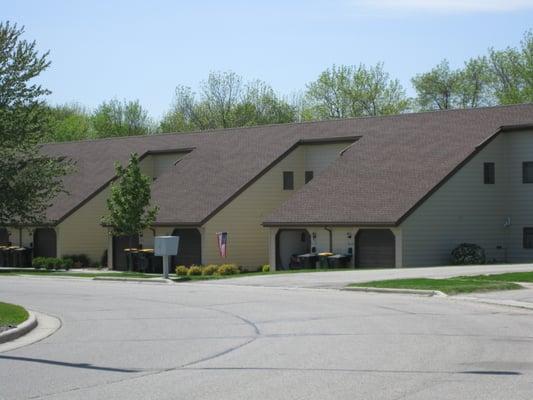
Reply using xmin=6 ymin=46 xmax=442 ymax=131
xmin=349 ymin=277 xmax=522 ymax=294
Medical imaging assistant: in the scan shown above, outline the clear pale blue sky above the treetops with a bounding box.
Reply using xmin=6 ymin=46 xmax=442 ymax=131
xmin=4 ymin=0 xmax=533 ymax=118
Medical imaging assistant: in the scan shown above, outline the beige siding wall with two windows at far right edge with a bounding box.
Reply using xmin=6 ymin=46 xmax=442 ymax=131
xmin=504 ymin=130 xmax=533 ymax=262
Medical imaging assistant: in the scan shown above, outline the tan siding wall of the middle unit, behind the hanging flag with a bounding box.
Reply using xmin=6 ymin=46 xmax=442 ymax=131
xmin=202 ymin=147 xmax=305 ymax=267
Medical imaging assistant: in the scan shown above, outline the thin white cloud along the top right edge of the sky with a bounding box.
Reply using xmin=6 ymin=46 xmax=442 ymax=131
xmin=356 ymin=0 xmax=533 ymax=13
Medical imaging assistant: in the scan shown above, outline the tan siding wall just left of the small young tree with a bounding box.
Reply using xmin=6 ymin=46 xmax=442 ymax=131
xmin=56 ymin=188 xmax=109 ymax=263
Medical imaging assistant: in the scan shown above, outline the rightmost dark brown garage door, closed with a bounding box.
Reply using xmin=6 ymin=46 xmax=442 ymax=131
xmin=355 ymin=229 xmax=395 ymax=268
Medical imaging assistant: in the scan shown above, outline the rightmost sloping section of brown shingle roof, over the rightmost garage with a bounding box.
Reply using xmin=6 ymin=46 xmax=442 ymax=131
xmin=264 ymin=104 xmax=533 ymax=225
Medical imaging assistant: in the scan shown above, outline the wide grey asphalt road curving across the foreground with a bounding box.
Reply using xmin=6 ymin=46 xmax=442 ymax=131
xmin=0 ymin=274 xmax=533 ymax=400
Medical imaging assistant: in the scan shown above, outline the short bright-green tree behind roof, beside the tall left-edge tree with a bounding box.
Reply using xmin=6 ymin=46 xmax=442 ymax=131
xmin=45 ymin=103 xmax=95 ymax=142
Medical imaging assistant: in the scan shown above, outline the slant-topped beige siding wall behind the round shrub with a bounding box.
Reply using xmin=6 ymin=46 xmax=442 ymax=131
xmin=401 ymin=135 xmax=506 ymax=267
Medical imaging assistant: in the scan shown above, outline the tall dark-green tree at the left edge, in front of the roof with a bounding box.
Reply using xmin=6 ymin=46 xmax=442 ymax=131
xmin=0 ymin=22 xmax=72 ymax=225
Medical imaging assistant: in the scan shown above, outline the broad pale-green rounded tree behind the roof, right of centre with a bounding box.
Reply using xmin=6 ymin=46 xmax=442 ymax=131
xmin=306 ymin=63 xmax=410 ymax=119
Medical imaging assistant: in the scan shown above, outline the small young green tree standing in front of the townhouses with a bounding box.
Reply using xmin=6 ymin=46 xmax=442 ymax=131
xmin=102 ymin=153 xmax=158 ymax=247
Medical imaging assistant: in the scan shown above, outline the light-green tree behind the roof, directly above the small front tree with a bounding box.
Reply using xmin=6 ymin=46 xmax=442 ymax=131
xmin=92 ymin=99 xmax=153 ymax=138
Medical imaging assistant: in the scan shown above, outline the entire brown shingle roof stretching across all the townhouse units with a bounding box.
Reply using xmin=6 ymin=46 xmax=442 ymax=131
xmin=44 ymin=104 xmax=533 ymax=225
